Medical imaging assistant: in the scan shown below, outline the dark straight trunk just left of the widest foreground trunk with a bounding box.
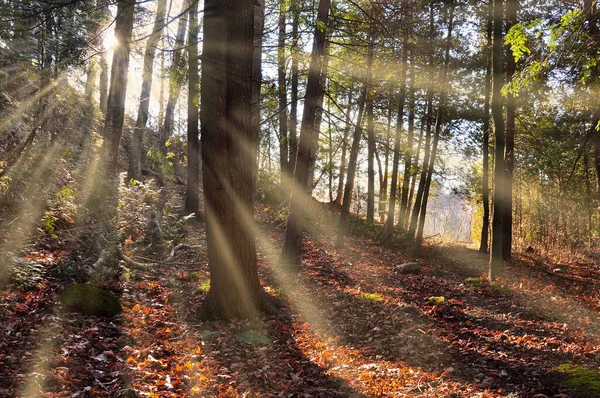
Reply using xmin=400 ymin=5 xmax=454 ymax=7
xmin=185 ymin=1 xmax=200 ymax=214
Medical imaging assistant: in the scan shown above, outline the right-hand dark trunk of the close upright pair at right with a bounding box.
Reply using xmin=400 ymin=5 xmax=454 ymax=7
xmin=502 ymin=0 xmax=518 ymax=263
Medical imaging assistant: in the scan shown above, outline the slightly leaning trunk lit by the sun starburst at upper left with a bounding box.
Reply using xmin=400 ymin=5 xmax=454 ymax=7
xmin=102 ymin=0 xmax=135 ymax=169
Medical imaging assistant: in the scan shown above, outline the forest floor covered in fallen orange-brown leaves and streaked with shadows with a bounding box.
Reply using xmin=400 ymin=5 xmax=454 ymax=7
xmin=0 ymin=184 xmax=600 ymax=398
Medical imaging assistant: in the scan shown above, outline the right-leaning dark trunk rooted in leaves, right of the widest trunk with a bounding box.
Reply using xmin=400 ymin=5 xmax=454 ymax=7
xmin=282 ymin=0 xmax=331 ymax=265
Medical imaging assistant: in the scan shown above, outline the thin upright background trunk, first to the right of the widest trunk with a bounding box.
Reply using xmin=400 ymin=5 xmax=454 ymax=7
xmin=277 ymin=1 xmax=289 ymax=176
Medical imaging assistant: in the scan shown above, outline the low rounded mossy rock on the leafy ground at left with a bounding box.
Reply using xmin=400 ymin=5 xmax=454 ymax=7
xmin=60 ymin=284 xmax=123 ymax=318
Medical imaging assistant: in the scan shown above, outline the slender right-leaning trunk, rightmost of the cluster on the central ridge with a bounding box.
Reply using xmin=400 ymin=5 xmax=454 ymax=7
xmin=414 ymin=1 xmax=456 ymax=257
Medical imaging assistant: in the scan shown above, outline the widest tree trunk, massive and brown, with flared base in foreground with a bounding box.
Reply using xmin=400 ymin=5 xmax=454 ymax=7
xmin=199 ymin=0 xmax=278 ymax=320
